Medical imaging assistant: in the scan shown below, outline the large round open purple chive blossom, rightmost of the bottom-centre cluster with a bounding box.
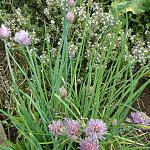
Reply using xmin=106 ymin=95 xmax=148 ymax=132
xmin=85 ymin=119 xmax=107 ymax=139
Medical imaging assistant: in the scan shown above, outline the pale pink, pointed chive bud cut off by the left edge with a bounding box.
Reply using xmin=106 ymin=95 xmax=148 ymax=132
xmin=0 ymin=24 xmax=11 ymax=39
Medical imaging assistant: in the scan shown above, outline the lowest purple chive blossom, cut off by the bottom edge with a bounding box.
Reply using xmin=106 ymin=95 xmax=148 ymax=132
xmin=79 ymin=138 xmax=99 ymax=150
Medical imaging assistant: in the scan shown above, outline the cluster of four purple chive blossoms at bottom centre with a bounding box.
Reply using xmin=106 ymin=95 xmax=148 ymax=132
xmin=48 ymin=118 xmax=107 ymax=150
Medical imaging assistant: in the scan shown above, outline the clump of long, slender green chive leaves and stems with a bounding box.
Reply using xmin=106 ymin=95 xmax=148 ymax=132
xmin=0 ymin=0 xmax=150 ymax=150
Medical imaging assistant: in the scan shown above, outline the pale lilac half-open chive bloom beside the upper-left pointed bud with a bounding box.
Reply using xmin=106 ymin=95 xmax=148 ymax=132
xmin=14 ymin=30 xmax=31 ymax=46
